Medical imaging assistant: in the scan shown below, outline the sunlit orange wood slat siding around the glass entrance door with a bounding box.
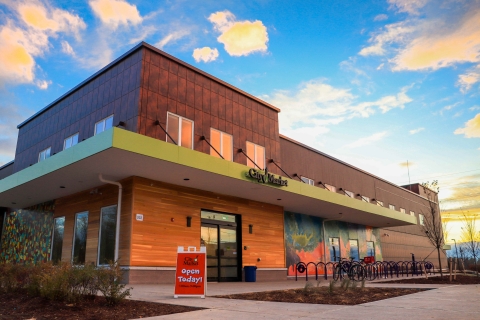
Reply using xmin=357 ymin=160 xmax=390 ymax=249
xmin=131 ymin=177 xmax=285 ymax=268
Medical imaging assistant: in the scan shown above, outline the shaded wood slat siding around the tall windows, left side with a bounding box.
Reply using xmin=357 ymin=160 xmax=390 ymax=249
xmin=54 ymin=178 xmax=132 ymax=265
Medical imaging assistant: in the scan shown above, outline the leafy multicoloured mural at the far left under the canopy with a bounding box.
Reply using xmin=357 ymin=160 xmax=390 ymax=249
xmin=0 ymin=202 xmax=54 ymax=263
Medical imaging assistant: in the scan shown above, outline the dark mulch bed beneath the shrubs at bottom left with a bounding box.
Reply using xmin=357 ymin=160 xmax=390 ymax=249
xmin=0 ymin=292 xmax=203 ymax=320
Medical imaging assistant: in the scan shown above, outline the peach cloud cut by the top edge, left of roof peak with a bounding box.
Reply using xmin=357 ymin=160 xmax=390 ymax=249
xmin=89 ymin=0 xmax=143 ymax=29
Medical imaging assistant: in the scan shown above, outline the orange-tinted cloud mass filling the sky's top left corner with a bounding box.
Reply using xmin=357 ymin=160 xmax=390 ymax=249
xmin=0 ymin=2 xmax=86 ymax=84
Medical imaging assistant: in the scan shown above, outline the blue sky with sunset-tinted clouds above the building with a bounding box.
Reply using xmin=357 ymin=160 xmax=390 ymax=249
xmin=0 ymin=0 xmax=480 ymax=244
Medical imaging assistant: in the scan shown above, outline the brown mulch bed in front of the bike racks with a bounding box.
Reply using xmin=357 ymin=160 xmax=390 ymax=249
xmin=215 ymin=287 xmax=426 ymax=305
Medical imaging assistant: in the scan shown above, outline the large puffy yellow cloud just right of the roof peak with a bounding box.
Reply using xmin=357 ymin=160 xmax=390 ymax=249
xmin=208 ymin=10 xmax=268 ymax=56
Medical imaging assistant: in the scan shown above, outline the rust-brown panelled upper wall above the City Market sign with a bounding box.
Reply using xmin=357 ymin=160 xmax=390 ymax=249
xmin=138 ymin=48 xmax=280 ymax=173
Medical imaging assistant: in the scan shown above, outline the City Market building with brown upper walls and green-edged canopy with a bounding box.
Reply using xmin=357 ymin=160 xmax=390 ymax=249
xmin=0 ymin=43 xmax=446 ymax=283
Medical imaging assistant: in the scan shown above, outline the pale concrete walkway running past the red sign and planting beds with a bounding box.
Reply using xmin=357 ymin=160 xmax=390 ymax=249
xmin=131 ymin=280 xmax=480 ymax=320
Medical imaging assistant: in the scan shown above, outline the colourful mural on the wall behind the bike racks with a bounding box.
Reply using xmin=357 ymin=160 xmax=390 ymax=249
xmin=284 ymin=212 xmax=382 ymax=276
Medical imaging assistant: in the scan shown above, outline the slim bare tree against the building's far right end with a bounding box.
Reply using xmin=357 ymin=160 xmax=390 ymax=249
xmin=420 ymin=180 xmax=445 ymax=277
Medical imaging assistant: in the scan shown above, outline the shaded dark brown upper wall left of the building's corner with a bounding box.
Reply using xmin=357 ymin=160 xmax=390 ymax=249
xmin=14 ymin=50 xmax=142 ymax=172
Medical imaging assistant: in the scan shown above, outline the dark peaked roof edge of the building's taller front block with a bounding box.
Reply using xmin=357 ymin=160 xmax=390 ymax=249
xmin=17 ymin=41 xmax=280 ymax=129
